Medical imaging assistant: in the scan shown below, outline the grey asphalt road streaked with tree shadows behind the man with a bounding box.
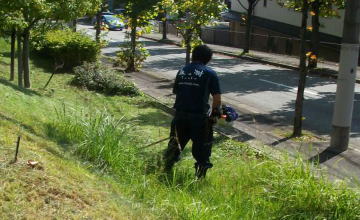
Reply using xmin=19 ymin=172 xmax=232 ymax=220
xmin=79 ymin=26 xmax=360 ymax=152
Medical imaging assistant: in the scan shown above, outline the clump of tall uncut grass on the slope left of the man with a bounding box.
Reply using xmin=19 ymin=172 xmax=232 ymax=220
xmin=47 ymin=106 xmax=143 ymax=173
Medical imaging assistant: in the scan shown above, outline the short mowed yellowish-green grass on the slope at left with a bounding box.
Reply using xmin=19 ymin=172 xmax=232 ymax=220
xmin=0 ymin=38 xmax=156 ymax=219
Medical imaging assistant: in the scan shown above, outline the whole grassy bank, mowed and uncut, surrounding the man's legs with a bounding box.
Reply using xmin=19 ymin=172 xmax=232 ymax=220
xmin=0 ymin=37 xmax=360 ymax=219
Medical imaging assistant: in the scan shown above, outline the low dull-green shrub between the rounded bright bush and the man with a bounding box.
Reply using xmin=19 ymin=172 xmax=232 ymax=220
xmin=72 ymin=62 xmax=140 ymax=95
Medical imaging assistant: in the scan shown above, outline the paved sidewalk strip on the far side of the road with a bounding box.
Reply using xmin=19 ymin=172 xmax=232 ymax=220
xmin=143 ymin=32 xmax=360 ymax=83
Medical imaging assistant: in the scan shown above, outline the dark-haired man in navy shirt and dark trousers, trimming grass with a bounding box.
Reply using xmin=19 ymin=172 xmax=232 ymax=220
xmin=164 ymin=45 xmax=221 ymax=178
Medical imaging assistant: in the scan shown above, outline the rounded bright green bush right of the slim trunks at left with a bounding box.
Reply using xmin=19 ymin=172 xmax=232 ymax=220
xmin=32 ymin=30 xmax=100 ymax=69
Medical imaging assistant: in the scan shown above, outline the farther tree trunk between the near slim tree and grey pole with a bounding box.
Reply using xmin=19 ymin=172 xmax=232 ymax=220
xmin=309 ymin=0 xmax=320 ymax=69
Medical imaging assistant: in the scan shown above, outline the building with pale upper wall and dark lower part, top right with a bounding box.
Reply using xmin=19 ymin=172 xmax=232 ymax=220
xmin=223 ymin=0 xmax=344 ymax=61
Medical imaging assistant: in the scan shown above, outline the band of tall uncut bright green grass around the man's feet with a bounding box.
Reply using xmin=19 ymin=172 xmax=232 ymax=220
xmin=48 ymin=105 xmax=360 ymax=219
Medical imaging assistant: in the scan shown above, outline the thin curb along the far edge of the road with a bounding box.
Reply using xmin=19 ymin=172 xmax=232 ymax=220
xmin=141 ymin=36 xmax=360 ymax=84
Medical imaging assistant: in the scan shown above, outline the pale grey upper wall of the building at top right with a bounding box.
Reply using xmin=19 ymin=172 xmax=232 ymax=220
xmin=231 ymin=0 xmax=344 ymax=37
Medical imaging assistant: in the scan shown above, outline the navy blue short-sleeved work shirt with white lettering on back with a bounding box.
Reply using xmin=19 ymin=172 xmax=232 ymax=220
xmin=173 ymin=62 xmax=221 ymax=115
